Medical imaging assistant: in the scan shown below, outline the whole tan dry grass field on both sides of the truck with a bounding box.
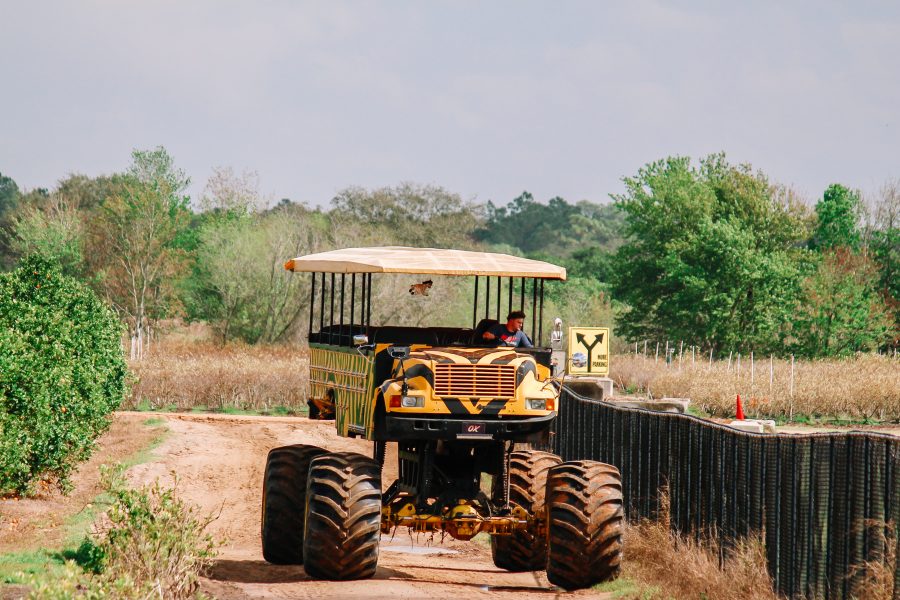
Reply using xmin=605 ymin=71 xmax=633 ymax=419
xmin=123 ymin=340 xmax=900 ymax=423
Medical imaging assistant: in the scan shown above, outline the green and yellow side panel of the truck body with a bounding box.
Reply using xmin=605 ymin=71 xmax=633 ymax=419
xmin=309 ymin=344 xmax=374 ymax=437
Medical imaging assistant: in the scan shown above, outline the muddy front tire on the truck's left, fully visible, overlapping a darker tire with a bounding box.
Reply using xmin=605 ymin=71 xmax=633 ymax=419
xmin=303 ymin=452 xmax=381 ymax=580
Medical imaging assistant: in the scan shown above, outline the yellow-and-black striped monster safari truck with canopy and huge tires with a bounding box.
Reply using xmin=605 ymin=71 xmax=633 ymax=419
xmin=262 ymin=247 xmax=623 ymax=589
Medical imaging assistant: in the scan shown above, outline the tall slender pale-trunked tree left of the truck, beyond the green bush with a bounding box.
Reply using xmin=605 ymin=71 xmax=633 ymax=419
xmin=87 ymin=148 xmax=190 ymax=357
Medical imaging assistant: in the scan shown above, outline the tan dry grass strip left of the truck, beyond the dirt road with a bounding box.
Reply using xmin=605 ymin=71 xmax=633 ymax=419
xmin=123 ymin=341 xmax=309 ymax=411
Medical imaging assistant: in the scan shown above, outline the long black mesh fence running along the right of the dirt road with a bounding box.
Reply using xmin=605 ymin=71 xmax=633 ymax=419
xmin=551 ymin=388 xmax=900 ymax=599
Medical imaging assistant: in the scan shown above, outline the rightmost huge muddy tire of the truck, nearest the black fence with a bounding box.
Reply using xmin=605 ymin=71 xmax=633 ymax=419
xmin=547 ymin=460 xmax=624 ymax=590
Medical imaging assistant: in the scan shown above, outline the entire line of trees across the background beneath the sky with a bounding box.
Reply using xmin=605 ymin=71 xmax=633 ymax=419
xmin=0 ymin=147 xmax=900 ymax=357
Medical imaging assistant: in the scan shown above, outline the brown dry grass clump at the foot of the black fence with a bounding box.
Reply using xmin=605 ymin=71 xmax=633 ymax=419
xmin=622 ymin=521 xmax=780 ymax=600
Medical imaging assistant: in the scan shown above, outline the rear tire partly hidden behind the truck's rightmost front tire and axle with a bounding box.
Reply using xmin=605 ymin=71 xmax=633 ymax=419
xmin=491 ymin=450 xmax=562 ymax=571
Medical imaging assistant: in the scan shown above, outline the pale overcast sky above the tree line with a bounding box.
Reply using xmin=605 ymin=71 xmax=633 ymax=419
xmin=0 ymin=0 xmax=900 ymax=205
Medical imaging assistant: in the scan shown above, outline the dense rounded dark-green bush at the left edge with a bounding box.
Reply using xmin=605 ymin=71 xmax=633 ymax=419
xmin=0 ymin=257 xmax=127 ymax=495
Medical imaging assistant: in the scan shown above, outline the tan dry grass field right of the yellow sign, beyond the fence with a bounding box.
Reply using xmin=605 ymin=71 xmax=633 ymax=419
xmin=610 ymin=352 xmax=900 ymax=422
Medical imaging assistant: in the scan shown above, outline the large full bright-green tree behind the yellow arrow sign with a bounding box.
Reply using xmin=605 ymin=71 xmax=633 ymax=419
xmin=613 ymin=155 xmax=807 ymax=350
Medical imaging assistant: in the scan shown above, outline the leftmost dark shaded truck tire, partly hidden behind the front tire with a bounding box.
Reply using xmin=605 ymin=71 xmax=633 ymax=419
xmin=262 ymin=444 xmax=325 ymax=565
